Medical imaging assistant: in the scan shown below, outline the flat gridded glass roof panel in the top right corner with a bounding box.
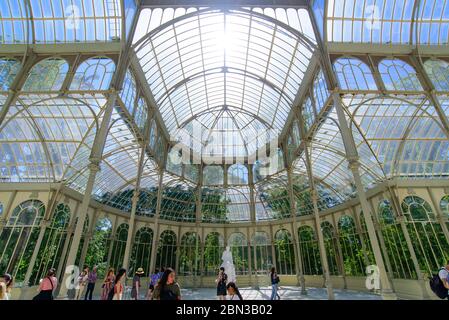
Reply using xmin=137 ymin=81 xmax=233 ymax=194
xmin=326 ymin=0 xmax=449 ymax=46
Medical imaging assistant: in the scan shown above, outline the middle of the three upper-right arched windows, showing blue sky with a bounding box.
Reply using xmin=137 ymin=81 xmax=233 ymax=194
xmin=379 ymin=59 xmax=423 ymax=91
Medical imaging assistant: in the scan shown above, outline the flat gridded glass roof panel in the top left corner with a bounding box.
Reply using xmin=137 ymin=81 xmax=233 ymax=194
xmin=0 ymin=0 xmax=122 ymax=44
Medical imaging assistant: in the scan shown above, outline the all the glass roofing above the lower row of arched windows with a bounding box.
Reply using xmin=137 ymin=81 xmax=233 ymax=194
xmin=0 ymin=0 xmax=449 ymax=223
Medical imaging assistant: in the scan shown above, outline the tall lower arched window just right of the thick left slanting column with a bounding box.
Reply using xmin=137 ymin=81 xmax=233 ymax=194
xmin=84 ymin=218 xmax=112 ymax=277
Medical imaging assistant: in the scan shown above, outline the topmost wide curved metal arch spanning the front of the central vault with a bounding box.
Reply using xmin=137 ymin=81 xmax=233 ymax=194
xmin=132 ymin=8 xmax=317 ymax=53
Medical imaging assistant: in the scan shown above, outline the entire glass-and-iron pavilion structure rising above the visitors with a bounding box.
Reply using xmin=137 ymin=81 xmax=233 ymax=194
xmin=0 ymin=0 xmax=449 ymax=299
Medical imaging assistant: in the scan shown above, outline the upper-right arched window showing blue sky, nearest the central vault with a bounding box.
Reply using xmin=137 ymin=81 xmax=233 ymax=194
xmin=334 ymin=58 xmax=377 ymax=90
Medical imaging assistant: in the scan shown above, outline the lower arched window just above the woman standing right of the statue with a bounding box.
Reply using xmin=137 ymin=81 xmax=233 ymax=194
xmin=274 ymin=229 xmax=296 ymax=274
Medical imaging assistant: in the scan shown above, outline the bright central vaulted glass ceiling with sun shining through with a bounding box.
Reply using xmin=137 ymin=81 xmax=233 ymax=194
xmin=134 ymin=9 xmax=315 ymax=157
